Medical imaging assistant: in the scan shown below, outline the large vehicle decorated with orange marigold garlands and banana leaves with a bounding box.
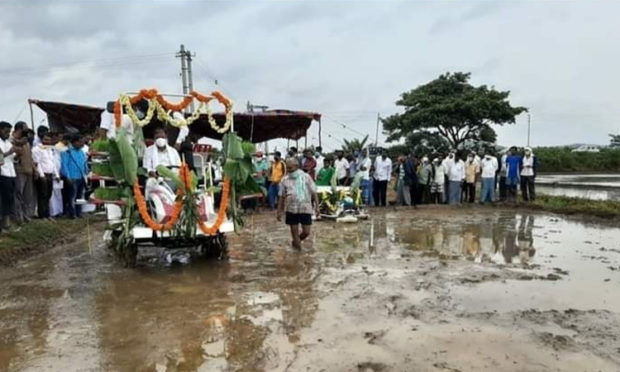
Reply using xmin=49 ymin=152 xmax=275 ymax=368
xmin=91 ymin=90 xmax=261 ymax=266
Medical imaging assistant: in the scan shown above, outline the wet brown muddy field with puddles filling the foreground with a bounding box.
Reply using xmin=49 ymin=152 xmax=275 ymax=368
xmin=0 ymin=208 xmax=620 ymax=371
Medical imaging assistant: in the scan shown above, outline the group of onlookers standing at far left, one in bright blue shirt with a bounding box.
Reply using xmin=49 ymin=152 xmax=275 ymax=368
xmin=0 ymin=121 xmax=90 ymax=232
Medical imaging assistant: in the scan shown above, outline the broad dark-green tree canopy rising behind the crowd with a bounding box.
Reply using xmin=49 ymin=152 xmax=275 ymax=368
xmin=383 ymin=72 xmax=527 ymax=148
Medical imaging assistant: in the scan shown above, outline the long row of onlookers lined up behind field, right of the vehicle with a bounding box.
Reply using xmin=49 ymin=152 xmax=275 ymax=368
xmin=255 ymin=147 xmax=538 ymax=209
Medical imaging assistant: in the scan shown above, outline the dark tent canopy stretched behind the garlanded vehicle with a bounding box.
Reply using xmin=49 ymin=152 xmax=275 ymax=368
xmin=29 ymin=99 xmax=321 ymax=143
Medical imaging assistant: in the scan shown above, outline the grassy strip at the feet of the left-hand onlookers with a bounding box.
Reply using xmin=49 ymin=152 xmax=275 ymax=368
xmin=0 ymin=219 xmax=86 ymax=252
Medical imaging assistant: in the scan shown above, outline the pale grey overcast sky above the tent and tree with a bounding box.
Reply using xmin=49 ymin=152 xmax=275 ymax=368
xmin=0 ymin=0 xmax=620 ymax=148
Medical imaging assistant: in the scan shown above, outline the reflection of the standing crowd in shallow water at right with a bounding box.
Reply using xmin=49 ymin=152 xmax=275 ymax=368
xmin=388 ymin=214 xmax=536 ymax=264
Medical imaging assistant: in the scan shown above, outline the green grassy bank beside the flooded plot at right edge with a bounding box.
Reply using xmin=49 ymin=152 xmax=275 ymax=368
xmin=530 ymin=195 xmax=620 ymax=218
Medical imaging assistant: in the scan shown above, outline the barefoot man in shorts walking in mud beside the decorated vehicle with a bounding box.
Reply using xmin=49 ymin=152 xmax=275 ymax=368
xmin=277 ymin=158 xmax=319 ymax=249
